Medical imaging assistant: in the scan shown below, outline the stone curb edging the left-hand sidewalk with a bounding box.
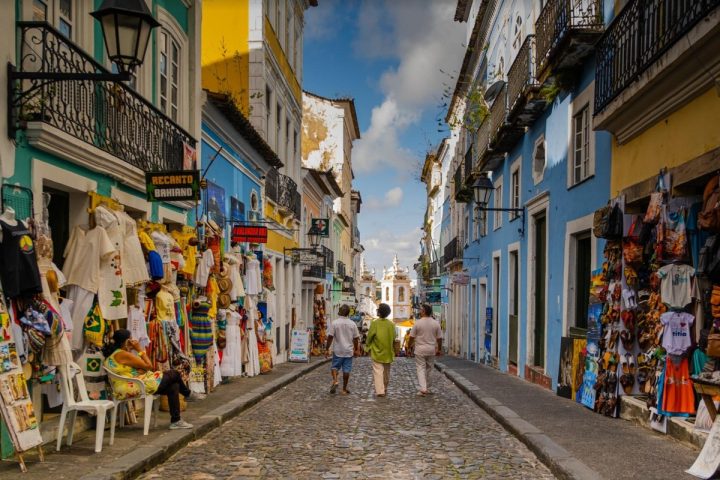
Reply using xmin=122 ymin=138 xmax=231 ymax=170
xmin=79 ymin=359 xmax=329 ymax=480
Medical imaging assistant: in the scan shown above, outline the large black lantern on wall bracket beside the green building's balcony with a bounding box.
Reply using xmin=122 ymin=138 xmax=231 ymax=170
xmin=90 ymin=0 xmax=160 ymax=73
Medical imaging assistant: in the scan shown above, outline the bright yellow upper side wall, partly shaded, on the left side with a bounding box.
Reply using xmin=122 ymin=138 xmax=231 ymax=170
xmin=202 ymin=0 xmax=250 ymax=115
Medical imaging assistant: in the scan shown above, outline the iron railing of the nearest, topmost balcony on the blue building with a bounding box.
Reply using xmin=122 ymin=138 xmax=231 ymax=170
xmin=535 ymin=0 xmax=604 ymax=72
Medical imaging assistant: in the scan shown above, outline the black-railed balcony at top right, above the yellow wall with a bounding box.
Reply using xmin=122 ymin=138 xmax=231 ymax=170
xmin=595 ymin=0 xmax=720 ymax=143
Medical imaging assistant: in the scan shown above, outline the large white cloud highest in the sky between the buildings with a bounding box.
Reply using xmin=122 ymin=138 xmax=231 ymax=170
xmin=353 ymin=0 xmax=465 ymax=172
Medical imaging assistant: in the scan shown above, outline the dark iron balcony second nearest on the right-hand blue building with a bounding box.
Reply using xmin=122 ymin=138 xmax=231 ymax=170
xmin=507 ymin=35 xmax=547 ymax=127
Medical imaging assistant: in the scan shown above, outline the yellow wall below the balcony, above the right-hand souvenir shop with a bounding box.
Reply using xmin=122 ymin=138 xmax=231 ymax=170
xmin=610 ymin=88 xmax=720 ymax=195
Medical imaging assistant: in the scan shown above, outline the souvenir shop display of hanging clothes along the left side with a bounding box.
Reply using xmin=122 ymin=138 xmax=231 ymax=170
xmin=0 ymin=187 xmax=274 ymax=460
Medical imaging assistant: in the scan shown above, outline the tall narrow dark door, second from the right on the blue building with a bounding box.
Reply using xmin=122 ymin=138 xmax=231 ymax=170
xmin=533 ymin=215 xmax=547 ymax=368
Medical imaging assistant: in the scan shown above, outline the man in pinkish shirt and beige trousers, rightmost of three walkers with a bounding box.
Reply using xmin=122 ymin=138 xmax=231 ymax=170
xmin=410 ymin=304 xmax=442 ymax=397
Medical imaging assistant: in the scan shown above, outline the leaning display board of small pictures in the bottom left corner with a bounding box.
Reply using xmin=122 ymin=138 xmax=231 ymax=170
xmin=0 ymin=341 xmax=42 ymax=452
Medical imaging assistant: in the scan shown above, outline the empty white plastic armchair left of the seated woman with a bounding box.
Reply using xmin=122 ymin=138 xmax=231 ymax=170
xmin=56 ymin=362 xmax=115 ymax=453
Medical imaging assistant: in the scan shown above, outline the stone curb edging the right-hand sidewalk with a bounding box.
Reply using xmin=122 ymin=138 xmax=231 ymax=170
xmin=435 ymin=362 xmax=602 ymax=480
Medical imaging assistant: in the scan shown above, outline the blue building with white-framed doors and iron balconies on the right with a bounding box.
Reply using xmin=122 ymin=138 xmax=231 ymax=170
xmin=445 ymin=1 xmax=611 ymax=388
